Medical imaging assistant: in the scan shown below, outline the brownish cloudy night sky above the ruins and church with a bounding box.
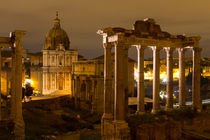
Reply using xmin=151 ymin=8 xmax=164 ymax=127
xmin=0 ymin=0 xmax=210 ymax=58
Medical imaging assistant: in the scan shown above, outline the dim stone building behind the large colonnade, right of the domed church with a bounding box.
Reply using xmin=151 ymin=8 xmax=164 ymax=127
xmin=72 ymin=55 xmax=135 ymax=113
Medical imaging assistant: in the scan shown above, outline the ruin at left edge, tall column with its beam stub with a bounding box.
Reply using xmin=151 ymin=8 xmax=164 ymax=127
xmin=0 ymin=30 xmax=25 ymax=140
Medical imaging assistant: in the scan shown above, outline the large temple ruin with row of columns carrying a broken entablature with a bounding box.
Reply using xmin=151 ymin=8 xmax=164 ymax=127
xmin=97 ymin=18 xmax=202 ymax=140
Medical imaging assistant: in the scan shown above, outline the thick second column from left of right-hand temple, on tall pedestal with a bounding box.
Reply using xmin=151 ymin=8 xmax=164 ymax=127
xmin=114 ymin=42 xmax=130 ymax=140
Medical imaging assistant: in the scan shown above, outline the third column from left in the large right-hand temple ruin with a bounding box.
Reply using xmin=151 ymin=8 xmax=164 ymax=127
xmin=136 ymin=45 xmax=145 ymax=114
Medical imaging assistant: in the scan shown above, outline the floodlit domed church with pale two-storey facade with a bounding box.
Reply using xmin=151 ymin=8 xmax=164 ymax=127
xmin=42 ymin=15 xmax=78 ymax=95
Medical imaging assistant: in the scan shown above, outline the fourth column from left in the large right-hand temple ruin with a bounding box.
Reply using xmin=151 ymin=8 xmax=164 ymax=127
xmin=152 ymin=46 xmax=161 ymax=113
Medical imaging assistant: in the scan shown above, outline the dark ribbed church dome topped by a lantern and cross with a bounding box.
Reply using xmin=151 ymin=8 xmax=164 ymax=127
xmin=44 ymin=13 xmax=70 ymax=50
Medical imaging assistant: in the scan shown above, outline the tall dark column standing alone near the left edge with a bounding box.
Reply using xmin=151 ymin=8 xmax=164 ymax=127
xmin=14 ymin=31 xmax=25 ymax=140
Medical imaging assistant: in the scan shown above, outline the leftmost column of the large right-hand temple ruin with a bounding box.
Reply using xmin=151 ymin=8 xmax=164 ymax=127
xmin=103 ymin=43 xmax=113 ymax=118
